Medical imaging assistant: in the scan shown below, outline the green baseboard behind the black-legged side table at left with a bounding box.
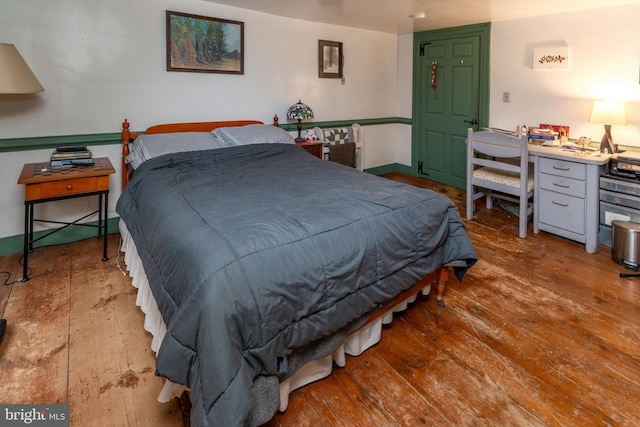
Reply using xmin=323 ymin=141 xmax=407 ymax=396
xmin=0 ymin=217 xmax=120 ymax=256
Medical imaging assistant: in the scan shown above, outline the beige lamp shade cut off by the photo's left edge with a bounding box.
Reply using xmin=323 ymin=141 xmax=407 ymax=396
xmin=0 ymin=43 xmax=44 ymax=94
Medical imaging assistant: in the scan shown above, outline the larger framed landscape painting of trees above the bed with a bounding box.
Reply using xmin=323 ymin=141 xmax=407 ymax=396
xmin=166 ymin=10 xmax=244 ymax=74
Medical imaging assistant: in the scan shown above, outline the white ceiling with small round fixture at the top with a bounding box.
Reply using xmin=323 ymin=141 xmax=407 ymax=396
xmin=205 ymin=0 xmax=640 ymax=34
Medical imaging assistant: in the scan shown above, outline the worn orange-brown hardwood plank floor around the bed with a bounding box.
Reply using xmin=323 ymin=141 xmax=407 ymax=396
xmin=0 ymin=174 xmax=640 ymax=426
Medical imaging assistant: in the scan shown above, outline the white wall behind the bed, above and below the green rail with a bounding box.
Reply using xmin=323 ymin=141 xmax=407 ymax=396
xmin=0 ymin=0 xmax=398 ymax=238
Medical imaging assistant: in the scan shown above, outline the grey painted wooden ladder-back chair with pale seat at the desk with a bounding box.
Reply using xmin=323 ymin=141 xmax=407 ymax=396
xmin=467 ymin=129 xmax=533 ymax=238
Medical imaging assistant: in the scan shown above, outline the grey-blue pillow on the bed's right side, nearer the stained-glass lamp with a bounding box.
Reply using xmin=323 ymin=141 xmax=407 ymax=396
xmin=211 ymin=124 xmax=295 ymax=147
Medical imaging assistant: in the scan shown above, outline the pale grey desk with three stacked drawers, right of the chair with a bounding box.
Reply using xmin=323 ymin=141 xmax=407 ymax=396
xmin=529 ymin=144 xmax=611 ymax=253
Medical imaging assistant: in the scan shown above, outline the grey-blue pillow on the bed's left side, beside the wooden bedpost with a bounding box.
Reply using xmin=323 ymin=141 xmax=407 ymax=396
xmin=125 ymin=132 xmax=222 ymax=169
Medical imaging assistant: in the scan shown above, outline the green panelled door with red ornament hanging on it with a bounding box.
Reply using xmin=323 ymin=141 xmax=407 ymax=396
xmin=412 ymin=24 xmax=485 ymax=188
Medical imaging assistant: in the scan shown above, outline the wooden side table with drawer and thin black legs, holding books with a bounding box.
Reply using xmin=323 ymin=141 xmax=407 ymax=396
xmin=18 ymin=157 xmax=115 ymax=282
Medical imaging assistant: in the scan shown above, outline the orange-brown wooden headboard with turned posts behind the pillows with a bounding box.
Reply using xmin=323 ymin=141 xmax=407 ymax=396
xmin=122 ymin=116 xmax=278 ymax=189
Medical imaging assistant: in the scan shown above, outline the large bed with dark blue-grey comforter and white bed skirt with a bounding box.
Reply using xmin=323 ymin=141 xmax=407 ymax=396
xmin=116 ymin=120 xmax=476 ymax=426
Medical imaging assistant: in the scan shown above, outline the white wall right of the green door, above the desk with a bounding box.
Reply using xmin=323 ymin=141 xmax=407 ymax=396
xmin=490 ymin=4 xmax=640 ymax=146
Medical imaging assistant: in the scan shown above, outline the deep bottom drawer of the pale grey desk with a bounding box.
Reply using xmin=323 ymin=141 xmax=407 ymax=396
xmin=538 ymin=190 xmax=585 ymax=235
